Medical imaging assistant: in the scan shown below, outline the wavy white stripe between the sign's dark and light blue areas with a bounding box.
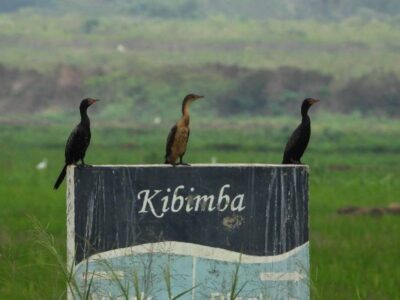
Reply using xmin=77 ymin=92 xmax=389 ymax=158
xmin=75 ymin=241 xmax=308 ymax=265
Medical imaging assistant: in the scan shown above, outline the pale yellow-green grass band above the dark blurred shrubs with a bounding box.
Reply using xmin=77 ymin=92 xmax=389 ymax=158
xmin=0 ymin=11 xmax=400 ymax=81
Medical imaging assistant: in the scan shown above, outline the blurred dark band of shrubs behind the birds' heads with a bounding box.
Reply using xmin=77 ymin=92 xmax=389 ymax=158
xmin=0 ymin=64 xmax=400 ymax=118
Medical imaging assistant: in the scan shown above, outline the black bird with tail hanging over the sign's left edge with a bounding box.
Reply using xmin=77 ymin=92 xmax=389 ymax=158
xmin=54 ymin=98 xmax=99 ymax=189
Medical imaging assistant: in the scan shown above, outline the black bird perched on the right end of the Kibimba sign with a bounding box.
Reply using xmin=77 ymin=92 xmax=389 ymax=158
xmin=282 ymin=98 xmax=319 ymax=164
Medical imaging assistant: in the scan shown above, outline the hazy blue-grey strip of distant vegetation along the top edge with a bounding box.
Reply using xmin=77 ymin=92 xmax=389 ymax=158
xmin=0 ymin=0 xmax=400 ymax=20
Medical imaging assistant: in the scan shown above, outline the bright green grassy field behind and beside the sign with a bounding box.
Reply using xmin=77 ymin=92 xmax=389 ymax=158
xmin=0 ymin=115 xmax=400 ymax=300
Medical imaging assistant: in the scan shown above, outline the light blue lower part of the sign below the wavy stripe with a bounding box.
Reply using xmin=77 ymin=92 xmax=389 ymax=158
xmin=75 ymin=243 xmax=310 ymax=300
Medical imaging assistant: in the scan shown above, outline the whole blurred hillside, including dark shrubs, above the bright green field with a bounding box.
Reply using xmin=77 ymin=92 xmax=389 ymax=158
xmin=0 ymin=0 xmax=400 ymax=121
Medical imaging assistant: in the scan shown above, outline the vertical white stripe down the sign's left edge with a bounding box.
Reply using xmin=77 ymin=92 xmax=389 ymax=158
xmin=66 ymin=166 xmax=75 ymax=300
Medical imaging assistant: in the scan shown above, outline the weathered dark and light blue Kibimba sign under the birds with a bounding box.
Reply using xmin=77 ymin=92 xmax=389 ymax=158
xmin=67 ymin=164 xmax=309 ymax=300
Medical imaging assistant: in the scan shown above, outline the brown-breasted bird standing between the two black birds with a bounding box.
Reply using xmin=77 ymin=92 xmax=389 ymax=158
xmin=165 ymin=94 xmax=204 ymax=165
